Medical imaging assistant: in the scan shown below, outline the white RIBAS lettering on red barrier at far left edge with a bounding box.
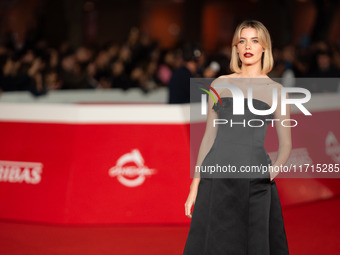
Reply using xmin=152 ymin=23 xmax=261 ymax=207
xmin=0 ymin=160 xmax=43 ymax=184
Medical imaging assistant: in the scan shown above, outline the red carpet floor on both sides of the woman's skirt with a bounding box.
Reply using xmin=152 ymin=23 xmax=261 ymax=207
xmin=0 ymin=197 xmax=340 ymax=255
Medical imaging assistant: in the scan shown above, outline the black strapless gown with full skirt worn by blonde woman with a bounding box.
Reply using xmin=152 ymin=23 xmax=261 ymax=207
xmin=183 ymin=97 xmax=289 ymax=255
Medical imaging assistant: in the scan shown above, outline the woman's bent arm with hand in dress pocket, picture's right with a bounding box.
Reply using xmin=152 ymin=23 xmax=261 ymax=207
xmin=270 ymin=84 xmax=292 ymax=181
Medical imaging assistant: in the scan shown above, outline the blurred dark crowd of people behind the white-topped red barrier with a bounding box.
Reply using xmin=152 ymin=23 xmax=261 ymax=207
xmin=0 ymin=28 xmax=340 ymax=96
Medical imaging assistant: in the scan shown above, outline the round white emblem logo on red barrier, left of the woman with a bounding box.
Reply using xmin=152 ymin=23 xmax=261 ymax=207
xmin=109 ymin=149 xmax=156 ymax=187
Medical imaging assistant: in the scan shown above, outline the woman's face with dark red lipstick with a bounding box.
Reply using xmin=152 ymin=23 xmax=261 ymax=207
xmin=237 ymin=27 xmax=264 ymax=65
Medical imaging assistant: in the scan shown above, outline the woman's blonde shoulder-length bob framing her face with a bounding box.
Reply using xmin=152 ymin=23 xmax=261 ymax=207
xmin=230 ymin=20 xmax=274 ymax=74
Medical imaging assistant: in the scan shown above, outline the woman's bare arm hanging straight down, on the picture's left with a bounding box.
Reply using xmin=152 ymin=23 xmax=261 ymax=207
xmin=185 ymin=83 xmax=218 ymax=218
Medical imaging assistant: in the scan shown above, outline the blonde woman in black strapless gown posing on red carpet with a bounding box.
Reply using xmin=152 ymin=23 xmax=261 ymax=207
xmin=184 ymin=20 xmax=292 ymax=255
